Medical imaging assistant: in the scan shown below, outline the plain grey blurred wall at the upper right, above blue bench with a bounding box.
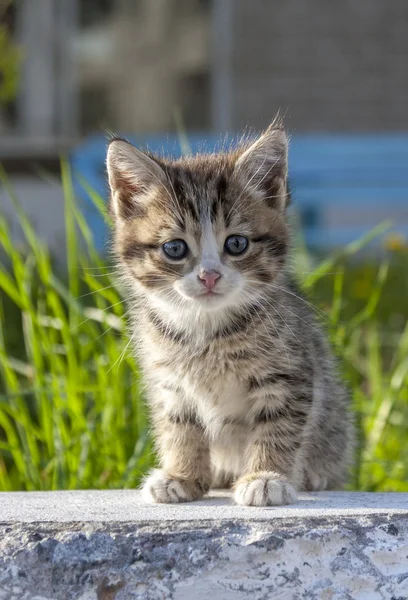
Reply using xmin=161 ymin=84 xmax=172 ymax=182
xmin=230 ymin=0 xmax=408 ymax=132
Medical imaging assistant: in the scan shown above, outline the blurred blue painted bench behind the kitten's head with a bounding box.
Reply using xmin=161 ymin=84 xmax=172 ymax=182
xmin=71 ymin=134 xmax=408 ymax=249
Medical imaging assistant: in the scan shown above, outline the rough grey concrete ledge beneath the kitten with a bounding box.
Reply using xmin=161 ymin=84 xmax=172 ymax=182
xmin=0 ymin=491 xmax=408 ymax=600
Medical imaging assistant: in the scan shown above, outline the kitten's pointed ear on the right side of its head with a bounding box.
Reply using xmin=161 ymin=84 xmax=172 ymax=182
xmin=235 ymin=119 xmax=289 ymax=210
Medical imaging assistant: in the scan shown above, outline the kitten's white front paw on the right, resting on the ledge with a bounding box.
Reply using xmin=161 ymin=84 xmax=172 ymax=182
xmin=234 ymin=472 xmax=297 ymax=506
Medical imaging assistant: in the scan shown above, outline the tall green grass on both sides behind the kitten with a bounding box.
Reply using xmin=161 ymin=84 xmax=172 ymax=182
xmin=0 ymin=162 xmax=408 ymax=491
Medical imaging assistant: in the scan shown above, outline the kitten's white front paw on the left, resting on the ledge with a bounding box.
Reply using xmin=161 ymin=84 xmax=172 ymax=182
xmin=142 ymin=469 xmax=204 ymax=504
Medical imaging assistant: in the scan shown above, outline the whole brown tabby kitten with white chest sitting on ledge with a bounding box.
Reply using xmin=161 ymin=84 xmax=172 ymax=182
xmin=107 ymin=121 xmax=351 ymax=506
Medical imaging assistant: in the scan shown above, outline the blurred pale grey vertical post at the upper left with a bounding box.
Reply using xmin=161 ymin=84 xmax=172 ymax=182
xmin=17 ymin=0 xmax=78 ymax=140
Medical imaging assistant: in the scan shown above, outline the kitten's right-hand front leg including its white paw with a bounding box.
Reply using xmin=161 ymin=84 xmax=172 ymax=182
xmin=234 ymin=410 xmax=301 ymax=506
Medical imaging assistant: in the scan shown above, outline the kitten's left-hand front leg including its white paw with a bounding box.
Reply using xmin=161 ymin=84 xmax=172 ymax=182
xmin=143 ymin=416 xmax=211 ymax=503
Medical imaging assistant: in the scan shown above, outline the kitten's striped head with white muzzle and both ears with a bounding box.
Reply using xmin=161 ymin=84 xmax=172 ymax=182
xmin=107 ymin=122 xmax=288 ymax=312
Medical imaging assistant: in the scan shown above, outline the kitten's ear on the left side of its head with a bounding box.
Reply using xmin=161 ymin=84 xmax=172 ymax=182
xmin=106 ymin=140 xmax=166 ymax=219
